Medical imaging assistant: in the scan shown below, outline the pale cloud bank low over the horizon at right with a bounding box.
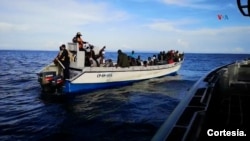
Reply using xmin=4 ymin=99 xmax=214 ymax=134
xmin=147 ymin=19 xmax=250 ymax=53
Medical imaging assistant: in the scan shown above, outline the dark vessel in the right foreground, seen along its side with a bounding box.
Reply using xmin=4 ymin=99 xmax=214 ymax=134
xmin=152 ymin=0 xmax=250 ymax=141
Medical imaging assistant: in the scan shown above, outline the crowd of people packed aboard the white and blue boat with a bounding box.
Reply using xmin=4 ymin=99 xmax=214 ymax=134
xmin=54 ymin=32 xmax=184 ymax=79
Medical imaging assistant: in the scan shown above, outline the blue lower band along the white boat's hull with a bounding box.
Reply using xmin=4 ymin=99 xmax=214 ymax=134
xmin=64 ymin=72 xmax=177 ymax=94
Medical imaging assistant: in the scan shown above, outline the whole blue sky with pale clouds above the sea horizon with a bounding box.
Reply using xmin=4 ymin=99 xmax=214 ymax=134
xmin=0 ymin=0 xmax=250 ymax=53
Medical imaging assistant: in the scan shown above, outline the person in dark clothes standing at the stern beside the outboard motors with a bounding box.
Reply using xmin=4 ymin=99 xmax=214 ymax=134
xmin=58 ymin=44 xmax=70 ymax=79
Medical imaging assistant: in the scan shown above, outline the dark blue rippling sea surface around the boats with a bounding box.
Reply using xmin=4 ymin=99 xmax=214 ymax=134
xmin=0 ymin=50 xmax=250 ymax=141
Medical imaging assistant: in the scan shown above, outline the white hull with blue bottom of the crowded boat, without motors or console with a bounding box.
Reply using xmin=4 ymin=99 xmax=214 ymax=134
xmin=63 ymin=62 xmax=181 ymax=93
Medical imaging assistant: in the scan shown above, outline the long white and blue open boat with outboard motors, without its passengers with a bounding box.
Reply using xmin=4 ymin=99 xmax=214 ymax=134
xmin=38 ymin=43 xmax=182 ymax=94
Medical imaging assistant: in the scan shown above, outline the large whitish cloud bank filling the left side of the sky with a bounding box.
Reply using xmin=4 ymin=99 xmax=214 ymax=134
xmin=0 ymin=0 xmax=129 ymax=50
